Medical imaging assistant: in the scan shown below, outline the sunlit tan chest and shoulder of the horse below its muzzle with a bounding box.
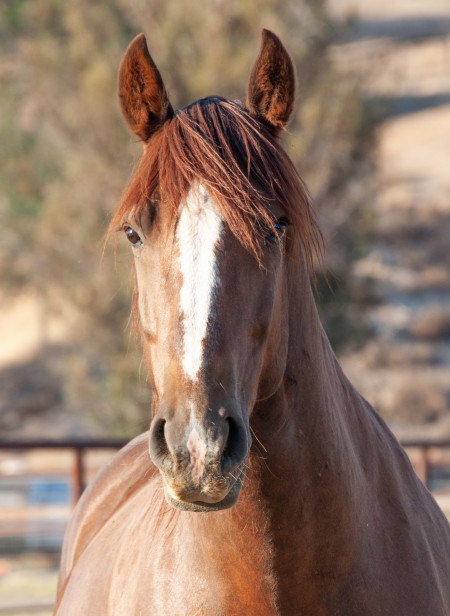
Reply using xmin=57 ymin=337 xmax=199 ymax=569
xmin=63 ymin=489 xmax=278 ymax=616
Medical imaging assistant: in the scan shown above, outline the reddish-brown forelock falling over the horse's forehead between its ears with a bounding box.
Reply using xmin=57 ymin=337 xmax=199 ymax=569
xmin=110 ymin=97 xmax=321 ymax=272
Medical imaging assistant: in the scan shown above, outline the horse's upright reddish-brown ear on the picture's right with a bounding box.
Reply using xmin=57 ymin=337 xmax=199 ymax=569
xmin=246 ymin=30 xmax=295 ymax=136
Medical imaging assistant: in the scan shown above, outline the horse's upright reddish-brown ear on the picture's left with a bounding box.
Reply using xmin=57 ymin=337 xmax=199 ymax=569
xmin=119 ymin=34 xmax=174 ymax=142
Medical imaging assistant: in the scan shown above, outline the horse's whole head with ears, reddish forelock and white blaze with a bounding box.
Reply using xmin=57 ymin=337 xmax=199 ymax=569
xmin=113 ymin=30 xmax=314 ymax=511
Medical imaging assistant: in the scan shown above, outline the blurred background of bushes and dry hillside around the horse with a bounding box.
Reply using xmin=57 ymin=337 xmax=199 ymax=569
xmin=0 ymin=0 xmax=450 ymax=615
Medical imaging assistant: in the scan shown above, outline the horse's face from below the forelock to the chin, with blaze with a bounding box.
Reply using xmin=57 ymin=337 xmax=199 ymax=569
xmin=125 ymin=185 xmax=286 ymax=511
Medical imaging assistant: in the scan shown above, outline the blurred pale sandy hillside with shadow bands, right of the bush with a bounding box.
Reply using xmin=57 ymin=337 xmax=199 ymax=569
xmin=329 ymin=0 xmax=450 ymax=437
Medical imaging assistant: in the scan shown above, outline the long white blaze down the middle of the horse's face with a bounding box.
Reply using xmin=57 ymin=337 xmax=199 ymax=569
xmin=177 ymin=186 xmax=223 ymax=381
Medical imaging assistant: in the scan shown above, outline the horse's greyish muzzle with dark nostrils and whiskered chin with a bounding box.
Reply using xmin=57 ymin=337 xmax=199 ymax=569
xmin=149 ymin=413 xmax=250 ymax=511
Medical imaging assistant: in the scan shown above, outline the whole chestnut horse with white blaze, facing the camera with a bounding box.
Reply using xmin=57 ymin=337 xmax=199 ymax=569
xmin=55 ymin=30 xmax=450 ymax=616
